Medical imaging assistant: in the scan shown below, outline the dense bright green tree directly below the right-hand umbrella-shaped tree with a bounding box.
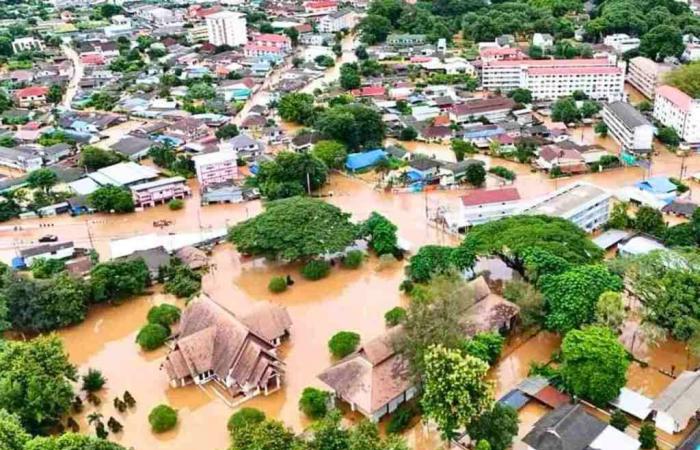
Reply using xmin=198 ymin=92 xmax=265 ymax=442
xmin=539 ymin=264 xmax=622 ymax=333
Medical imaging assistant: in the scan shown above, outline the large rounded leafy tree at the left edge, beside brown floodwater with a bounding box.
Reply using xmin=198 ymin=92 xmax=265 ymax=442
xmin=0 ymin=336 xmax=76 ymax=433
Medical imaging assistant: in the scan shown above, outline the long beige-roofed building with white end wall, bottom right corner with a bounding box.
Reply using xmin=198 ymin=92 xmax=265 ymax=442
xmin=650 ymin=370 xmax=700 ymax=434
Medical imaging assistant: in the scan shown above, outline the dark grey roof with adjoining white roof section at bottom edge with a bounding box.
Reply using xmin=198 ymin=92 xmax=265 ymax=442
xmin=523 ymin=404 xmax=640 ymax=450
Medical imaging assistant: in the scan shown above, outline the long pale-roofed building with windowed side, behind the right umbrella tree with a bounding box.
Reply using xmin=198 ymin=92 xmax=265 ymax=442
xmin=522 ymin=182 xmax=612 ymax=233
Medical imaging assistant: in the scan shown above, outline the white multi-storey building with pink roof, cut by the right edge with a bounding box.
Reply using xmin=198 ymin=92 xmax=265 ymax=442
xmin=654 ymin=85 xmax=700 ymax=147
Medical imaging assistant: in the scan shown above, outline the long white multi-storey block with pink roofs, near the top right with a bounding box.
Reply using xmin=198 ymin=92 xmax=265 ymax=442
xmin=482 ymin=57 xmax=625 ymax=101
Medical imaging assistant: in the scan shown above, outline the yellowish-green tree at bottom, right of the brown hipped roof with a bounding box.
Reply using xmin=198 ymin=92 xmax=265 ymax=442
xmin=421 ymin=345 xmax=493 ymax=439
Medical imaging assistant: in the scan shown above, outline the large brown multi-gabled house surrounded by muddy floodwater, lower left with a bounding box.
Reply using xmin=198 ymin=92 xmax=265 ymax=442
xmin=161 ymin=294 xmax=284 ymax=403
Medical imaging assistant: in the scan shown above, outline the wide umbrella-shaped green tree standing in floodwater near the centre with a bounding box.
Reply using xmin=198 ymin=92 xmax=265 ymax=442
xmin=228 ymin=197 xmax=357 ymax=261
